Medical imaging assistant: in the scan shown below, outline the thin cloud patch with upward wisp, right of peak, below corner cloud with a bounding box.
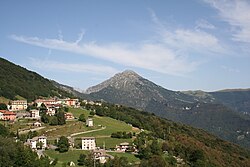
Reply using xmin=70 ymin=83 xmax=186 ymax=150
xmin=151 ymin=11 xmax=226 ymax=55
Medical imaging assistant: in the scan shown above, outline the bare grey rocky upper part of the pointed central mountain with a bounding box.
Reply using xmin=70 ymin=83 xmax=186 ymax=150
xmin=86 ymin=70 xmax=200 ymax=111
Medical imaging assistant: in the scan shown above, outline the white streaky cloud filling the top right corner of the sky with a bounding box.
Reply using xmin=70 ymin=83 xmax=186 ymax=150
xmin=204 ymin=0 xmax=250 ymax=43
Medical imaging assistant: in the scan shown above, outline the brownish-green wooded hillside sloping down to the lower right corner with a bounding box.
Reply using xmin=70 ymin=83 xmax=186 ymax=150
xmin=85 ymin=104 xmax=250 ymax=167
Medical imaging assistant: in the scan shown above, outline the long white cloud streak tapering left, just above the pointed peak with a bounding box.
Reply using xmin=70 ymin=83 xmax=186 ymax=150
xmin=11 ymin=35 xmax=197 ymax=75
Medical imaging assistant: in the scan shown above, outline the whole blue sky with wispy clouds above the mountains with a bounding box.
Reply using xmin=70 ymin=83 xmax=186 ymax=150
xmin=0 ymin=0 xmax=250 ymax=91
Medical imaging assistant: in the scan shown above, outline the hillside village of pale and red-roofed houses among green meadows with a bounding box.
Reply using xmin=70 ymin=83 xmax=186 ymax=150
xmin=0 ymin=97 xmax=140 ymax=166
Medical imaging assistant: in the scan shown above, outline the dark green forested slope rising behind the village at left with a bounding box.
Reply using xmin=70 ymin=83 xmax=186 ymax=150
xmin=0 ymin=58 xmax=73 ymax=101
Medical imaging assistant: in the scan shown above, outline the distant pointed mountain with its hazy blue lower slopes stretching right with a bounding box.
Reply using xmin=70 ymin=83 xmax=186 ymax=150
xmin=86 ymin=70 xmax=250 ymax=148
